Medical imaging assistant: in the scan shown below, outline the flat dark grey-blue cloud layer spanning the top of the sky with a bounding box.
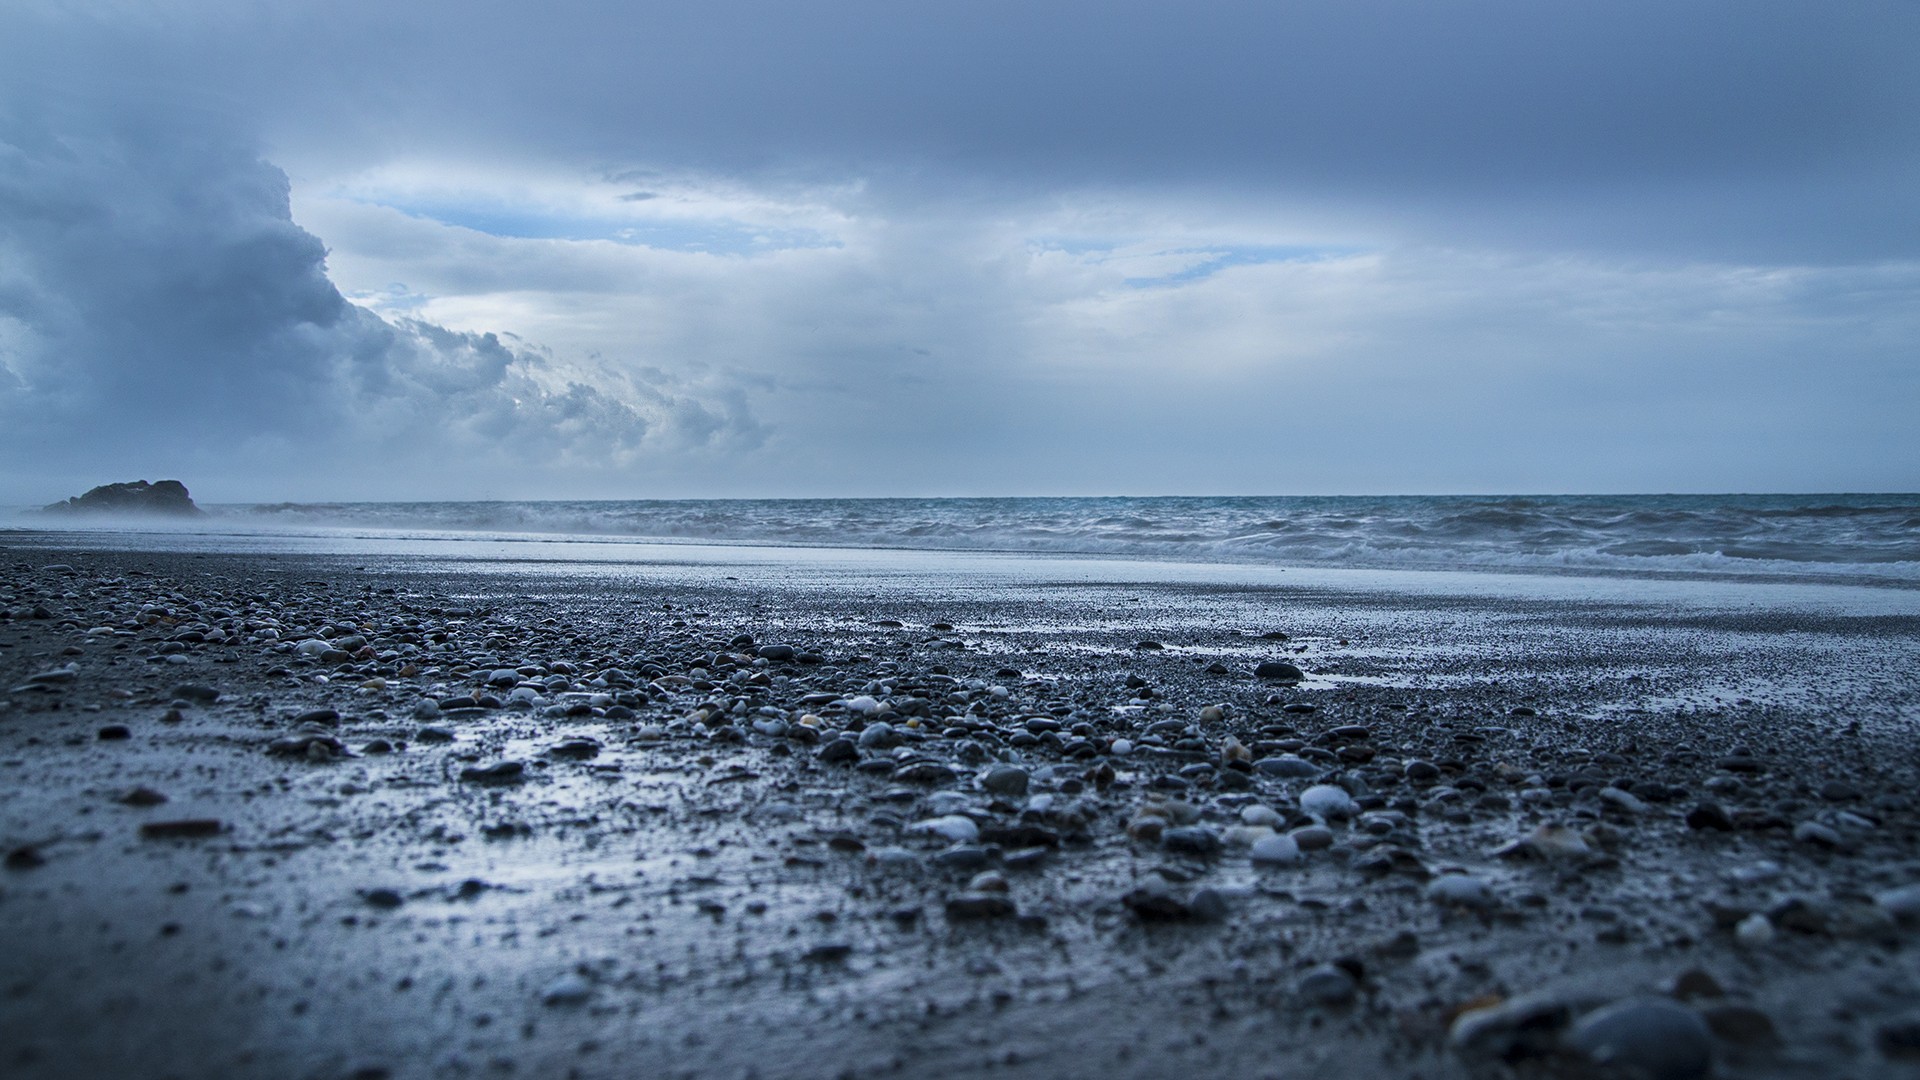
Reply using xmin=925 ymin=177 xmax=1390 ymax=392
xmin=10 ymin=0 xmax=1920 ymax=261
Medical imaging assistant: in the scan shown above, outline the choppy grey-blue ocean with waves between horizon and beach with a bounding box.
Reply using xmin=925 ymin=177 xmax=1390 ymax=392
xmin=13 ymin=494 xmax=1920 ymax=588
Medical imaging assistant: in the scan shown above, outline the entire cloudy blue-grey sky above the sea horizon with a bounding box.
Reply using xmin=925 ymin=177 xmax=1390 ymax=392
xmin=0 ymin=0 xmax=1920 ymax=503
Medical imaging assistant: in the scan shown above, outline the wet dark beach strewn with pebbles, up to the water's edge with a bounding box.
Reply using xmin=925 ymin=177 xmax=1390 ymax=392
xmin=0 ymin=532 xmax=1920 ymax=1080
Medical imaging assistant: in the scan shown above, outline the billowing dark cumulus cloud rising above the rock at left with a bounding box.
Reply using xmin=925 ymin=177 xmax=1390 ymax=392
xmin=0 ymin=117 xmax=764 ymax=498
